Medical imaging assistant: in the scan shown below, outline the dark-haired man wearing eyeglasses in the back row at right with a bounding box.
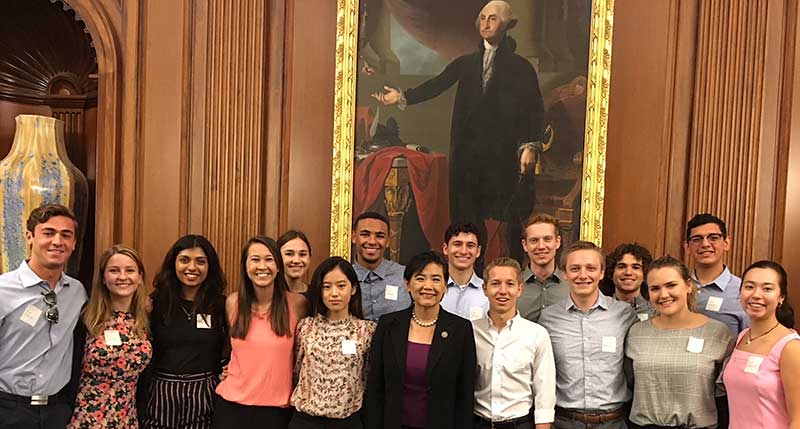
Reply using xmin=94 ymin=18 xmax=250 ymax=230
xmin=683 ymin=213 xmax=750 ymax=338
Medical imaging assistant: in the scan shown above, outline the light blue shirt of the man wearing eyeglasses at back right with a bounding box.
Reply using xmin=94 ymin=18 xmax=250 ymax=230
xmin=692 ymin=267 xmax=750 ymax=338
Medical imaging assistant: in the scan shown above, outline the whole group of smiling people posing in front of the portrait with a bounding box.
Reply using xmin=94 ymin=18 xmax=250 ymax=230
xmin=0 ymin=205 xmax=800 ymax=429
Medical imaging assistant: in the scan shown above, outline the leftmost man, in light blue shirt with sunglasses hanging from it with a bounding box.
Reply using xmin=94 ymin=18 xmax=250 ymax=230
xmin=0 ymin=204 xmax=86 ymax=429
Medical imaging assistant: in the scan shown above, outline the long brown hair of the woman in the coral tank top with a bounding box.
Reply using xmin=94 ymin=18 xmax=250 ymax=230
xmin=231 ymin=235 xmax=292 ymax=339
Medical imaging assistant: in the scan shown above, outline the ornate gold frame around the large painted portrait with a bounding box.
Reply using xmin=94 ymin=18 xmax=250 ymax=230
xmin=330 ymin=0 xmax=614 ymax=258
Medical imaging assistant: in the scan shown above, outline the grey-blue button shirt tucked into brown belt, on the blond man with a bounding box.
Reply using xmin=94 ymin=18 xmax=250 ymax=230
xmin=539 ymin=292 xmax=639 ymax=412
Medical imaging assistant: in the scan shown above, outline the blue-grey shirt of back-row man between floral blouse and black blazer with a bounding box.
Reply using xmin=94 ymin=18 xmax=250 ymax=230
xmin=353 ymin=259 xmax=411 ymax=321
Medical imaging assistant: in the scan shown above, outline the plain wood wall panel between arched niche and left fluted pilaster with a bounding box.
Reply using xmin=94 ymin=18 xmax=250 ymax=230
xmin=136 ymin=0 xmax=187 ymax=275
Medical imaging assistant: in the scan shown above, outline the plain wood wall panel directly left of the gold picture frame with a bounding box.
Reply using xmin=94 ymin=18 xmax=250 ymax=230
xmin=281 ymin=0 xmax=337 ymax=266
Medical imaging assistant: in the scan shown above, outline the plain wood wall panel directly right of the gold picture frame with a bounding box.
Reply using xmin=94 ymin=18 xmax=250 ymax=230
xmin=603 ymin=0 xmax=696 ymax=254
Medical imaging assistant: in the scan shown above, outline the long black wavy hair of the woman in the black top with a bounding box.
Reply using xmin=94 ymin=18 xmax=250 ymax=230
xmin=151 ymin=234 xmax=225 ymax=324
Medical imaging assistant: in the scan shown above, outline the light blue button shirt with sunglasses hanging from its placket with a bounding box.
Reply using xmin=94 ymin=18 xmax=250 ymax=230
xmin=0 ymin=261 xmax=86 ymax=396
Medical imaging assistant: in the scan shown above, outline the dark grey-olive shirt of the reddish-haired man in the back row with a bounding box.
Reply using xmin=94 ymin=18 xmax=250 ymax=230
xmin=517 ymin=267 xmax=569 ymax=322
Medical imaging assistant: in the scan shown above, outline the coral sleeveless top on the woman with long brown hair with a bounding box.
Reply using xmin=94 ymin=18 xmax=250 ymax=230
xmin=217 ymin=297 xmax=297 ymax=408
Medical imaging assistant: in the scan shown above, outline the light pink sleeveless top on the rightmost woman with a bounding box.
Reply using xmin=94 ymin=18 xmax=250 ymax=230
xmin=722 ymin=329 xmax=800 ymax=429
